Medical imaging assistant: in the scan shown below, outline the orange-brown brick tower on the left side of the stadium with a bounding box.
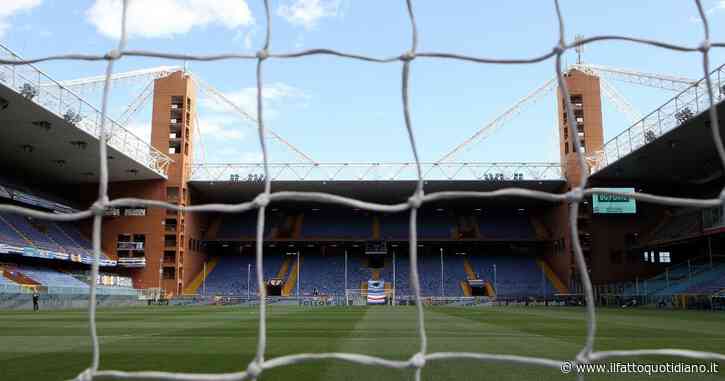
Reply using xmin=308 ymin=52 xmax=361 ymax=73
xmin=98 ymin=71 xmax=203 ymax=295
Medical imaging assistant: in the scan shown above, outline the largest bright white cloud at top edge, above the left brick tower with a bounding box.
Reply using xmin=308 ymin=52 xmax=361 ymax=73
xmin=86 ymin=0 xmax=254 ymax=38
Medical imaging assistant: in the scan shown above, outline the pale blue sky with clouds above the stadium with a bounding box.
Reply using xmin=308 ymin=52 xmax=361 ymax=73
xmin=0 ymin=0 xmax=725 ymax=162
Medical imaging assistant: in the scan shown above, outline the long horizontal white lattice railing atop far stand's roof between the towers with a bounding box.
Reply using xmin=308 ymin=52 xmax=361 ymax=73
xmin=189 ymin=162 xmax=563 ymax=184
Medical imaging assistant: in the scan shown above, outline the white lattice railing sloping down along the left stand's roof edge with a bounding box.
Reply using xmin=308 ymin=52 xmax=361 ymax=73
xmin=0 ymin=44 xmax=172 ymax=177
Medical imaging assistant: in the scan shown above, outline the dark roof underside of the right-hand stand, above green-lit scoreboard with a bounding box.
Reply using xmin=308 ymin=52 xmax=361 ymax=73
xmin=591 ymin=102 xmax=725 ymax=185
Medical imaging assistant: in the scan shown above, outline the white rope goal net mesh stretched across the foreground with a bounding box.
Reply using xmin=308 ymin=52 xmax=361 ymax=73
xmin=0 ymin=0 xmax=725 ymax=380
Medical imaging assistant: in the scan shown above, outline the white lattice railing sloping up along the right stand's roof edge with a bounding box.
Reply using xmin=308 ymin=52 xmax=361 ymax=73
xmin=592 ymin=65 xmax=725 ymax=172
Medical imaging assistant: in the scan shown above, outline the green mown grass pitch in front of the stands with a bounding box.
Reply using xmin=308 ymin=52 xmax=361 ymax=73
xmin=0 ymin=306 xmax=725 ymax=381
